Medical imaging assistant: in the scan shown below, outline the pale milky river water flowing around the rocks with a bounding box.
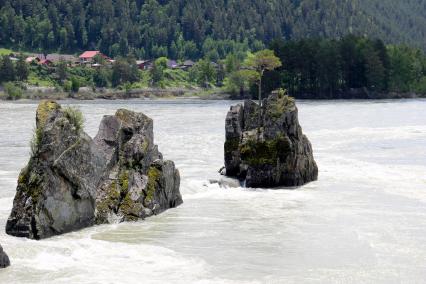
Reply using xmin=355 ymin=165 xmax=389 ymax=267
xmin=0 ymin=100 xmax=426 ymax=283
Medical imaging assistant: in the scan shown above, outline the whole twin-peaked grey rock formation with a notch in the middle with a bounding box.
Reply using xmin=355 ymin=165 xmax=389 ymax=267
xmin=6 ymin=101 xmax=182 ymax=239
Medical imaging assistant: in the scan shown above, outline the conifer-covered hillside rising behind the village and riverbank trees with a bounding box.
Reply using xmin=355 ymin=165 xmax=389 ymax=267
xmin=0 ymin=0 xmax=426 ymax=60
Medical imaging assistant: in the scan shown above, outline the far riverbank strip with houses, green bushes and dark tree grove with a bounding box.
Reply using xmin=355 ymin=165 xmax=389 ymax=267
xmin=0 ymin=35 xmax=426 ymax=100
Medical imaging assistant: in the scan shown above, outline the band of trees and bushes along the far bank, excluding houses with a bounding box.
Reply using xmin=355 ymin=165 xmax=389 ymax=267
xmin=0 ymin=35 xmax=426 ymax=99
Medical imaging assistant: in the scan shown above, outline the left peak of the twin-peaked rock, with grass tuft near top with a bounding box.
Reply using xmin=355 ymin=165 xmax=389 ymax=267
xmin=6 ymin=102 xmax=103 ymax=239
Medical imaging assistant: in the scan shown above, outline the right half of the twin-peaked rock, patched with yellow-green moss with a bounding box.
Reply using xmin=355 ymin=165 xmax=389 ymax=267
xmin=95 ymin=110 xmax=182 ymax=224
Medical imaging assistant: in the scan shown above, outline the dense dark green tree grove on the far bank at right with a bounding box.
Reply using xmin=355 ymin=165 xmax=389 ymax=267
xmin=263 ymin=36 xmax=426 ymax=98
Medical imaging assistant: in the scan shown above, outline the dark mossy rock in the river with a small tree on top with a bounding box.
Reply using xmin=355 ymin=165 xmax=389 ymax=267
xmin=225 ymin=93 xmax=318 ymax=187
